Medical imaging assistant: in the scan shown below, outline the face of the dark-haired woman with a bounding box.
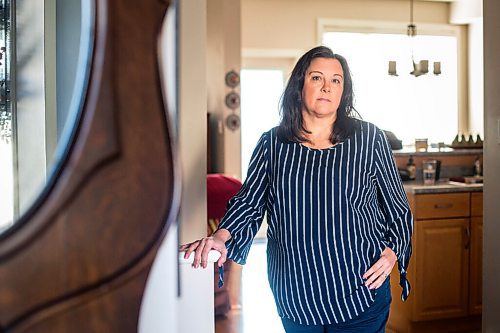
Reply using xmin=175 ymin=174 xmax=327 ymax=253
xmin=302 ymin=58 xmax=344 ymax=120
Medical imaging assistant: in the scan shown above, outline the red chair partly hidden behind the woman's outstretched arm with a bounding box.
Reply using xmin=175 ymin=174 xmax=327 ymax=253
xmin=207 ymin=174 xmax=242 ymax=316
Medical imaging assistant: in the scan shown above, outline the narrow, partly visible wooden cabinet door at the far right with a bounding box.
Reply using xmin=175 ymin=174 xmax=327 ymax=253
xmin=469 ymin=217 xmax=483 ymax=314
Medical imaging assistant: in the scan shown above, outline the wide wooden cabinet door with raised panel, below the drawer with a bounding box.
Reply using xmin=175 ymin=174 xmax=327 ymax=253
xmin=413 ymin=219 xmax=470 ymax=321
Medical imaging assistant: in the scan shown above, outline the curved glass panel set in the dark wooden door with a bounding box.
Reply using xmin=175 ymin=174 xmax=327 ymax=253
xmin=0 ymin=0 xmax=95 ymax=233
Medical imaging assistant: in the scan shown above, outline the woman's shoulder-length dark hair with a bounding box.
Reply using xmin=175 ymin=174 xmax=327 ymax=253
xmin=277 ymin=46 xmax=359 ymax=144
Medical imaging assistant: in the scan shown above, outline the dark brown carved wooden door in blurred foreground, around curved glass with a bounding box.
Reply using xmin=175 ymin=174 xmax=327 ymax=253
xmin=0 ymin=0 xmax=178 ymax=333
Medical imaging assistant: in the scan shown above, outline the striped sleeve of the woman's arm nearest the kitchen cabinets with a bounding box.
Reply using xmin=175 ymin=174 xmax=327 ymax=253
xmin=374 ymin=130 xmax=413 ymax=301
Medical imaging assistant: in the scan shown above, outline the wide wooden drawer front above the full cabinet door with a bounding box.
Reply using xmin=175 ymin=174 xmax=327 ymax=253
xmin=414 ymin=192 xmax=470 ymax=219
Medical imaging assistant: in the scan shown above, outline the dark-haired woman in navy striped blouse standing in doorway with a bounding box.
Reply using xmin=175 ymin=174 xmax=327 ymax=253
xmin=181 ymin=46 xmax=413 ymax=333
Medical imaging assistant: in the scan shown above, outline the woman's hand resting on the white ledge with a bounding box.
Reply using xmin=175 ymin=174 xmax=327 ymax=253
xmin=179 ymin=229 xmax=231 ymax=268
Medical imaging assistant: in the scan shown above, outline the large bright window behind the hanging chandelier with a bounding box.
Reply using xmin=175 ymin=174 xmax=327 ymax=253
xmin=322 ymin=29 xmax=458 ymax=145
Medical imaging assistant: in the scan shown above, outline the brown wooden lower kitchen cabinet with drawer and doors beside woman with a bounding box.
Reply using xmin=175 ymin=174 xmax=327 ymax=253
xmin=387 ymin=191 xmax=482 ymax=333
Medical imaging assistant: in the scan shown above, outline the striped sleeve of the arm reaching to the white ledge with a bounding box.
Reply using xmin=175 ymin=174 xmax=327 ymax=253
xmin=218 ymin=132 xmax=269 ymax=265
